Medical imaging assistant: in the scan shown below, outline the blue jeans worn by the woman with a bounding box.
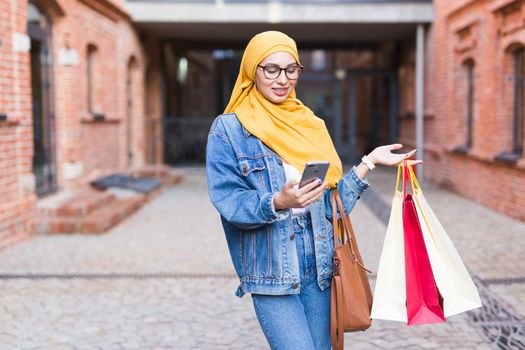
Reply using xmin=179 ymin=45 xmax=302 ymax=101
xmin=252 ymin=213 xmax=331 ymax=350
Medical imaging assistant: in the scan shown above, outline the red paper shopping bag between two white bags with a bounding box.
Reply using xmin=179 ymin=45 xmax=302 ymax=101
xmin=403 ymin=162 xmax=445 ymax=326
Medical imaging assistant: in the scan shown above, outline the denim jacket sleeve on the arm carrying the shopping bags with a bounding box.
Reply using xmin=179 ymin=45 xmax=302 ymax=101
xmin=324 ymin=166 xmax=370 ymax=220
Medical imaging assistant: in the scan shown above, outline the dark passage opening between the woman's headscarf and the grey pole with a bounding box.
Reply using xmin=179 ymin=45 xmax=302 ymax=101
xmin=296 ymin=45 xmax=399 ymax=165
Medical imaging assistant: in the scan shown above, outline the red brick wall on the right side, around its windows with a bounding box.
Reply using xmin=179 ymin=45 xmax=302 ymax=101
xmin=425 ymin=0 xmax=525 ymax=220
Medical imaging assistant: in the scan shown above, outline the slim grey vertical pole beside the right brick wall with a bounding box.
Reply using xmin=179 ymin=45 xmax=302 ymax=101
xmin=416 ymin=24 xmax=425 ymax=181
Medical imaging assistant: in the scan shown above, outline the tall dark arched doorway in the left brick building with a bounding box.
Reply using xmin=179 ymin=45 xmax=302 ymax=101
xmin=27 ymin=3 xmax=57 ymax=196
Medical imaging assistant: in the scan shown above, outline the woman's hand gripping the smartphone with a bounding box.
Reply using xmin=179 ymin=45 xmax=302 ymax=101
xmin=273 ymin=180 xmax=328 ymax=210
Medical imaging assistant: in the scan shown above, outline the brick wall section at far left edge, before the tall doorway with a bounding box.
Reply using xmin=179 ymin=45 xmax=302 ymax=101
xmin=0 ymin=0 xmax=35 ymax=247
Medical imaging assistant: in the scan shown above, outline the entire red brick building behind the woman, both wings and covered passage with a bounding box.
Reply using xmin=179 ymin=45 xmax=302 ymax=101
xmin=0 ymin=0 xmax=525 ymax=247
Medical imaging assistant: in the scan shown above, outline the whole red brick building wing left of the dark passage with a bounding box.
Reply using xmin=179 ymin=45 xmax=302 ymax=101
xmin=0 ymin=0 xmax=145 ymax=246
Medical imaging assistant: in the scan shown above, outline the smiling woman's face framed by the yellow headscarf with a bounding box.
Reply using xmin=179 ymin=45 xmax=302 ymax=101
xmin=255 ymin=52 xmax=298 ymax=103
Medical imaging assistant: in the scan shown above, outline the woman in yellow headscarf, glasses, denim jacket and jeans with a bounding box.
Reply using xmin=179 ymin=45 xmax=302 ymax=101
xmin=206 ymin=31 xmax=415 ymax=350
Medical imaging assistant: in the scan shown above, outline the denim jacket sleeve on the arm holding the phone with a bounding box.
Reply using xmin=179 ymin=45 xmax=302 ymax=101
xmin=206 ymin=117 xmax=289 ymax=229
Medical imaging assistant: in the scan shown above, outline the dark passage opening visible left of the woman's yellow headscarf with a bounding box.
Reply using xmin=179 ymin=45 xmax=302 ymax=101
xmin=162 ymin=43 xmax=242 ymax=165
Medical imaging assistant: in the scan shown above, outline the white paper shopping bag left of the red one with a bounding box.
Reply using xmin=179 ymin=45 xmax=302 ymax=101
xmin=371 ymin=166 xmax=407 ymax=322
